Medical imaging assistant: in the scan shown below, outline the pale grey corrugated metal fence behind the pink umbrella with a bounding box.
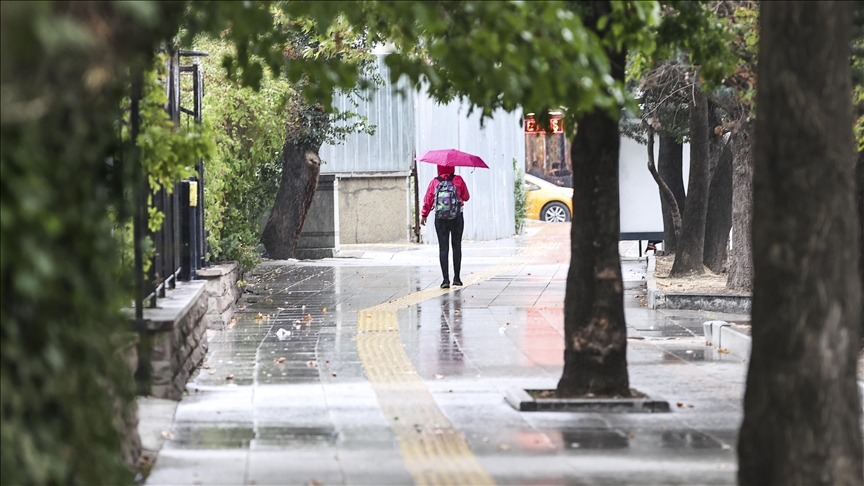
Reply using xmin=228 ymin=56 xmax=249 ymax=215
xmin=320 ymin=56 xmax=525 ymax=243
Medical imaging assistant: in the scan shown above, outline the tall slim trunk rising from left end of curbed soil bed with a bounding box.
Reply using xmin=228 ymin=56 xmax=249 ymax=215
xmin=671 ymin=87 xmax=710 ymax=277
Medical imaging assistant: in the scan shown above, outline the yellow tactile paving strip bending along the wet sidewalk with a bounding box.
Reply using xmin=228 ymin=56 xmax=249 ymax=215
xmin=357 ymin=237 xmax=557 ymax=485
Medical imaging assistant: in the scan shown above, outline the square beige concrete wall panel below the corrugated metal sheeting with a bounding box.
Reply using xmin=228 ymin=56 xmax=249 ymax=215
xmin=339 ymin=174 xmax=410 ymax=244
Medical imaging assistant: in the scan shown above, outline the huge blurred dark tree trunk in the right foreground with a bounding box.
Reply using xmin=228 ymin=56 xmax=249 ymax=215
xmin=738 ymin=1 xmax=864 ymax=485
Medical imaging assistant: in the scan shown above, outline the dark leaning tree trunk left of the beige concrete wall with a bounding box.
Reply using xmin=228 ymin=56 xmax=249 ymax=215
xmin=261 ymin=142 xmax=321 ymax=259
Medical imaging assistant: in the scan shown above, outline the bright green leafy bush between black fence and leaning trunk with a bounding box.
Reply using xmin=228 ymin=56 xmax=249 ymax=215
xmin=194 ymin=36 xmax=297 ymax=269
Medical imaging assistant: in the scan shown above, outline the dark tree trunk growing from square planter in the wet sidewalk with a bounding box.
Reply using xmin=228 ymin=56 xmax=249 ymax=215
xmin=558 ymin=38 xmax=630 ymax=397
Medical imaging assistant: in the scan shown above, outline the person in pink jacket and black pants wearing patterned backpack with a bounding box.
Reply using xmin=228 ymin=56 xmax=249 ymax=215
xmin=420 ymin=165 xmax=470 ymax=289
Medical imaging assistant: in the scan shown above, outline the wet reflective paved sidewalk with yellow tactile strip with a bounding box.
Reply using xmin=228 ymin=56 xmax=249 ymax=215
xmin=147 ymin=224 xmax=746 ymax=484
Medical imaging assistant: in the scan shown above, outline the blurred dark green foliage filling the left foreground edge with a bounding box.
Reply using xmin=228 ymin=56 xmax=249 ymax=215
xmin=0 ymin=2 xmax=186 ymax=484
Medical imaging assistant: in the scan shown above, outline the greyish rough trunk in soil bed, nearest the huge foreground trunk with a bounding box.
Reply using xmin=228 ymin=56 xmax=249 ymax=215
xmin=726 ymin=122 xmax=753 ymax=291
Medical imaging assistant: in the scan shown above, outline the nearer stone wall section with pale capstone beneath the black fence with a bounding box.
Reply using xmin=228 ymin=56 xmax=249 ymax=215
xmin=144 ymin=280 xmax=208 ymax=400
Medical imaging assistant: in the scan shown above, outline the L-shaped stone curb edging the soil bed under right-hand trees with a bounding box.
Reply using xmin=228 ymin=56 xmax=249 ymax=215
xmin=645 ymin=255 xmax=752 ymax=314
